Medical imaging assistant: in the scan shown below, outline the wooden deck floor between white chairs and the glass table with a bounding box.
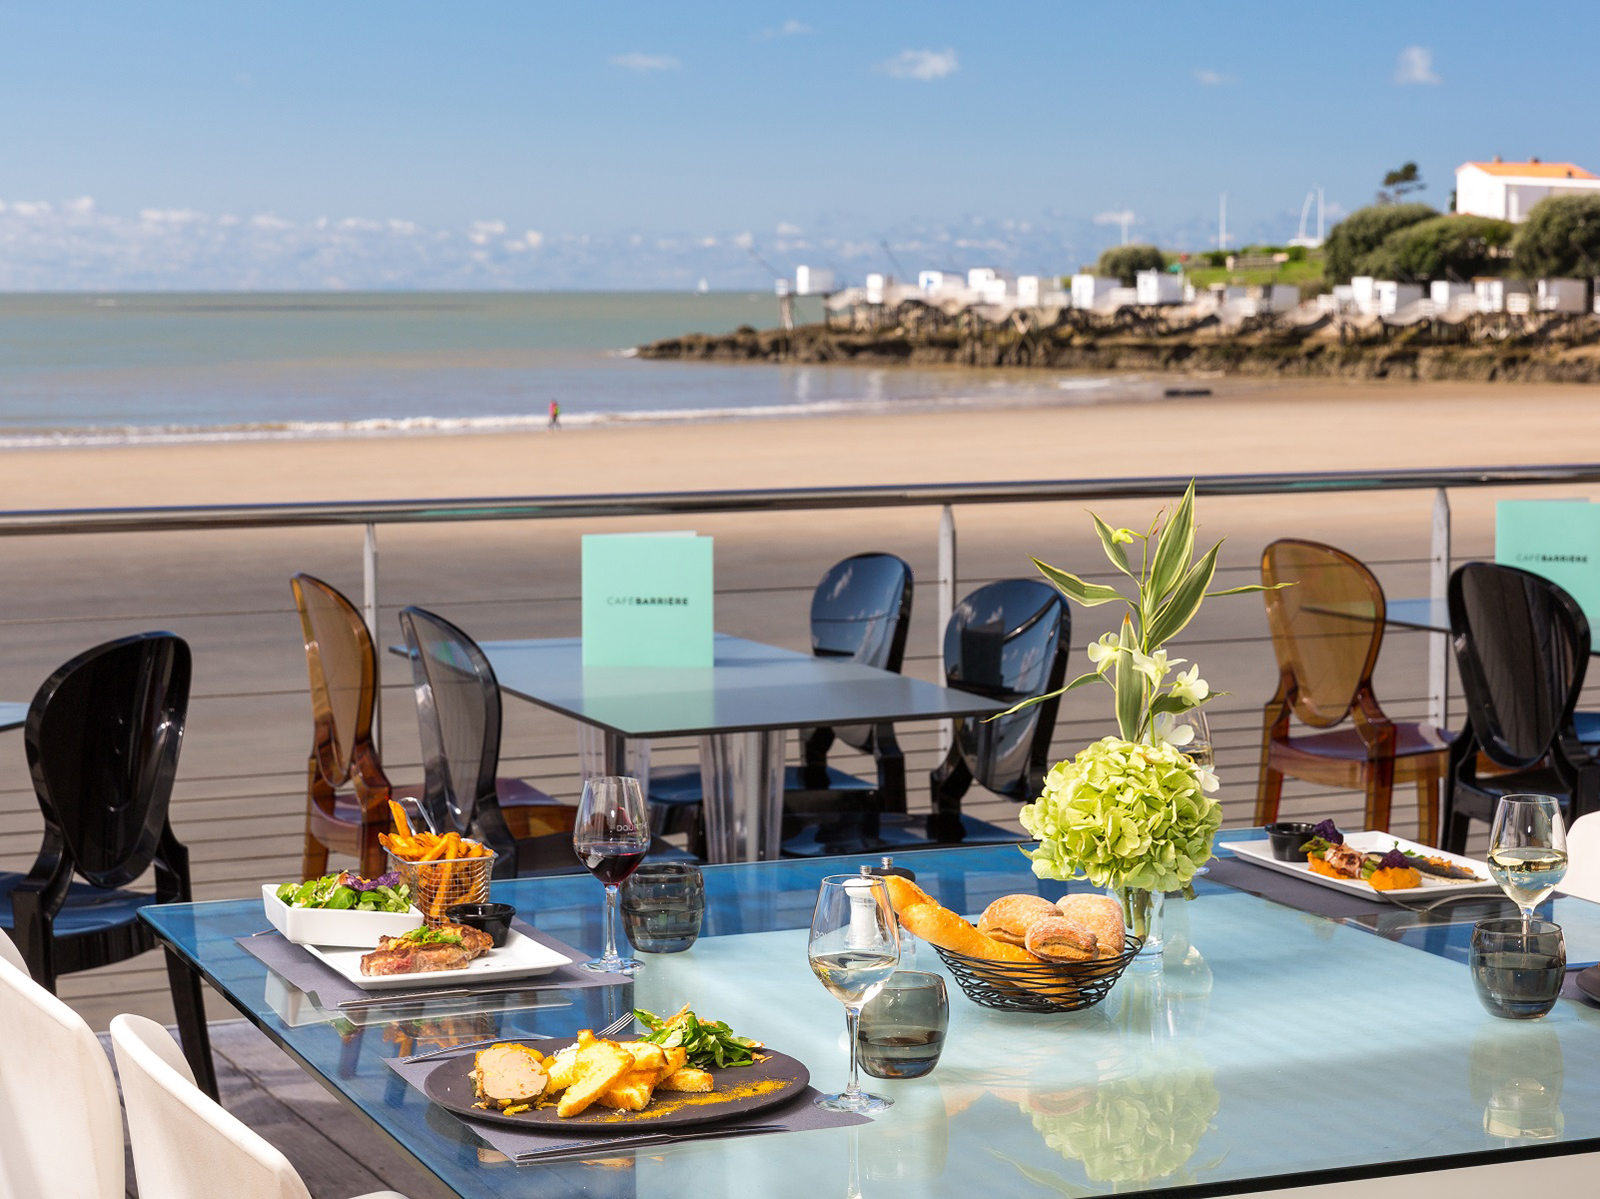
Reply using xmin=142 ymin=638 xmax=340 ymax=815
xmin=101 ymin=1020 xmax=454 ymax=1199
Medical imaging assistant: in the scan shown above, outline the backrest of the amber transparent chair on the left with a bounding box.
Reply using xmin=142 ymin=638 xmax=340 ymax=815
xmin=290 ymin=575 xmax=378 ymax=788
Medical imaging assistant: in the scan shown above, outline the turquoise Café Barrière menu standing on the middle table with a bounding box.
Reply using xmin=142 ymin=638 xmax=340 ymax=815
xmin=582 ymin=533 xmax=712 ymax=668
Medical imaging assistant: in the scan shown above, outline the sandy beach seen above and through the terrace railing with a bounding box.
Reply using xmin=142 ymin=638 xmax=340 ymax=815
xmin=0 ymin=371 xmax=1600 ymax=1015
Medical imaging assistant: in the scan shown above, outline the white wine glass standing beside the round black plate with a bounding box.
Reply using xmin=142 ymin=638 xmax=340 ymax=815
xmin=806 ymin=874 xmax=899 ymax=1111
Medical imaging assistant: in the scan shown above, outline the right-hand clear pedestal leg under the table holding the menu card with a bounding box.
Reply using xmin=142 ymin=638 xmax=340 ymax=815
xmin=701 ymin=730 xmax=789 ymax=861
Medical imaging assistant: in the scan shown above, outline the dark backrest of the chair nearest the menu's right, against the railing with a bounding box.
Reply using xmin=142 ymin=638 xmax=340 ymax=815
xmin=811 ymin=554 xmax=912 ymax=672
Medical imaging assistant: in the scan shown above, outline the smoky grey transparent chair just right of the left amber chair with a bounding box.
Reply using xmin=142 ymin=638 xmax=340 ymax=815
xmin=400 ymin=608 xmax=682 ymax=879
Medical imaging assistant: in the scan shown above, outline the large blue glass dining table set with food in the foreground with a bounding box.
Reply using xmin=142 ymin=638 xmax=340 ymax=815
xmin=144 ymin=831 xmax=1600 ymax=1199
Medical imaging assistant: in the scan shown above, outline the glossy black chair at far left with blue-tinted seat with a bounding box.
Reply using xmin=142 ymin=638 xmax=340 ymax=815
xmin=0 ymin=632 xmax=216 ymax=1095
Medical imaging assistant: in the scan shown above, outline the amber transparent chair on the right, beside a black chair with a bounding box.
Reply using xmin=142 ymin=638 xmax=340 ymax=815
xmin=1256 ymin=538 xmax=1451 ymax=845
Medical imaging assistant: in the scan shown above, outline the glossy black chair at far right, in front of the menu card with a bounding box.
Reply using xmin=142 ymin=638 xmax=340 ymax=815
xmin=1443 ymin=562 xmax=1600 ymax=853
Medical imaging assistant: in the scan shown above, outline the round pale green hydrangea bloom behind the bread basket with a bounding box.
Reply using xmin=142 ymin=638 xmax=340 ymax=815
xmin=1021 ymin=736 xmax=1222 ymax=892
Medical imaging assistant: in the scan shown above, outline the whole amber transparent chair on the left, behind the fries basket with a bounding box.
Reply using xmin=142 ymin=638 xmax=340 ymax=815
xmin=290 ymin=575 xmax=392 ymax=879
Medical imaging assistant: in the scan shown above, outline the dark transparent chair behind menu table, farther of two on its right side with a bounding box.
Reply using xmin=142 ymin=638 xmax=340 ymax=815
xmin=650 ymin=552 xmax=912 ymax=855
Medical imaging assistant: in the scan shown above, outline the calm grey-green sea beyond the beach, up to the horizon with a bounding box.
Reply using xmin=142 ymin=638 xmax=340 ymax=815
xmin=0 ymin=291 xmax=1162 ymax=447
